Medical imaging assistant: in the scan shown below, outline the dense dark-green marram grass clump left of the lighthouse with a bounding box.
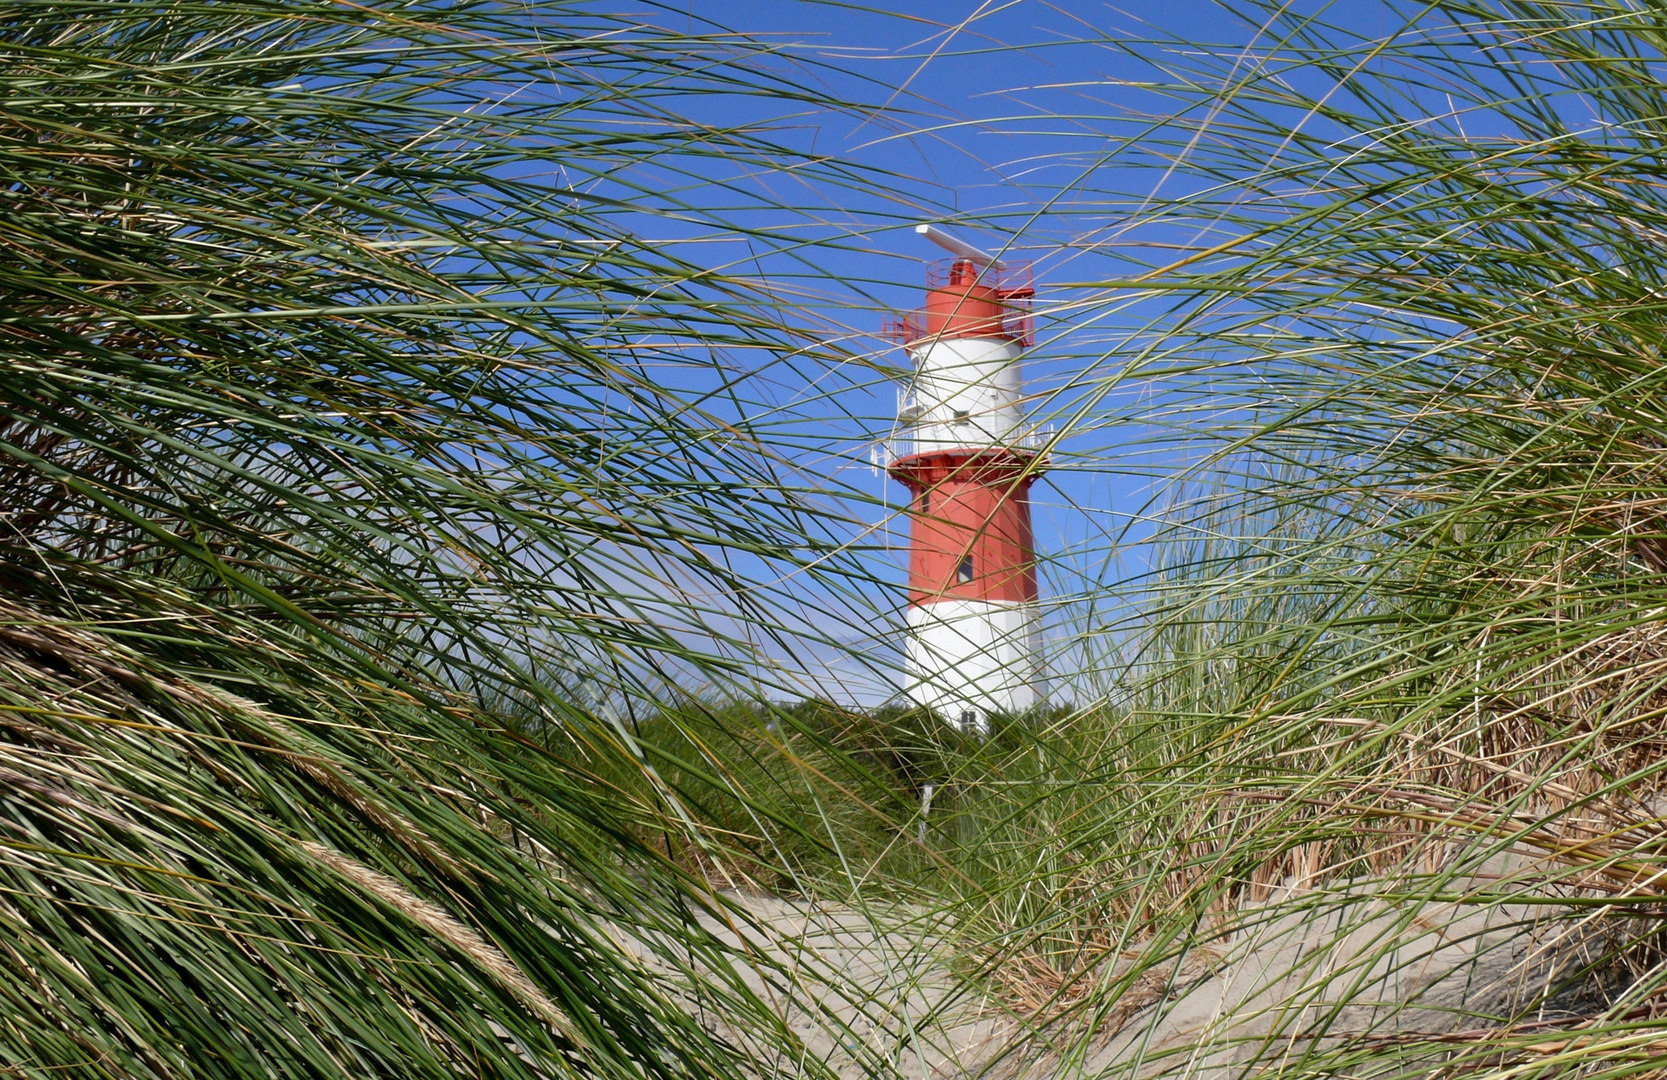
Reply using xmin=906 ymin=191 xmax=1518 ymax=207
xmin=0 ymin=0 xmax=893 ymax=1080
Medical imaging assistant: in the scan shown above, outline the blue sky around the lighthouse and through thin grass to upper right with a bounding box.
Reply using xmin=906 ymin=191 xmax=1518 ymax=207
xmin=566 ymin=0 xmax=1629 ymax=700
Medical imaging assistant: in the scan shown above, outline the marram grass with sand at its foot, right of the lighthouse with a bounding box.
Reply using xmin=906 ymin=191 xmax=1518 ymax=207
xmin=906 ymin=2 xmax=1667 ymax=1077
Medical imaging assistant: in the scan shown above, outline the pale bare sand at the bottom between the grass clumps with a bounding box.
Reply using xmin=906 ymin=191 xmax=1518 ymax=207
xmin=663 ymin=853 xmax=1613 ymax=1080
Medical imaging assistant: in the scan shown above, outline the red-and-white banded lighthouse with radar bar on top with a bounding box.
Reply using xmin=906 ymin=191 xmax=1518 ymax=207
xmin=885 ymin=225 xmax=1047 ymax=735
